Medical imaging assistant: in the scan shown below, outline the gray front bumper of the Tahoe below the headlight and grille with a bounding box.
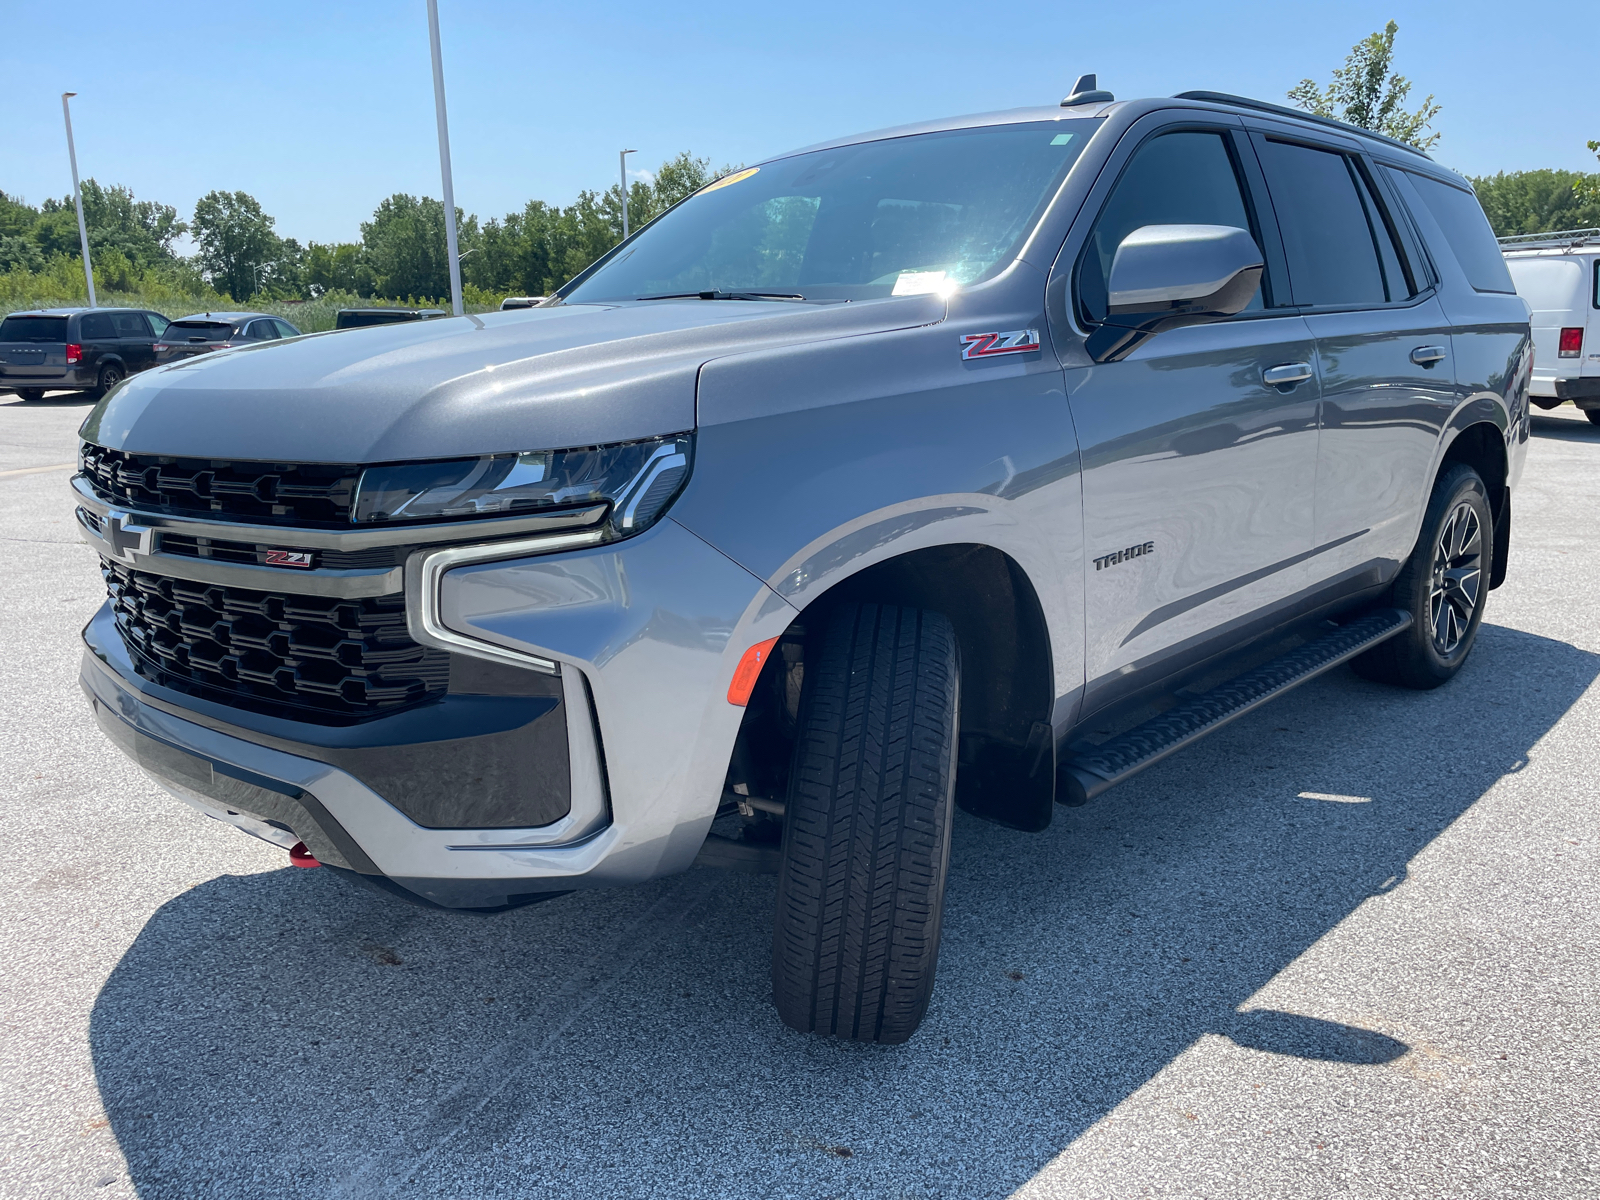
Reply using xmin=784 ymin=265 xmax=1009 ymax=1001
xmin=82 ymin=520 xmax=795 ymax=909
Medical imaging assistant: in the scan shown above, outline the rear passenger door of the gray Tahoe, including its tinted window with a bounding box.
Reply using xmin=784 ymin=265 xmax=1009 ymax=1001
xmin=1253 ymin=131 xmax=1456 ymax=592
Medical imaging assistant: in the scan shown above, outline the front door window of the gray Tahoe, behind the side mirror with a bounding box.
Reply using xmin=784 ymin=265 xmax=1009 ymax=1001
xmin=1078 ymin=130 xmax=1262 ymax=322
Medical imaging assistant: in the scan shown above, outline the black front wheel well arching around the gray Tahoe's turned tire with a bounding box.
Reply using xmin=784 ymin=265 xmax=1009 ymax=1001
xmin=728 ymin=544 xmax=1054 ymax=830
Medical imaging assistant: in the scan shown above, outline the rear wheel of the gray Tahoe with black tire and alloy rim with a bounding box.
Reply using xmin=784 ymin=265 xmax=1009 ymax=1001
xmin=1352 ymin=462 xmax=1494 ymax=690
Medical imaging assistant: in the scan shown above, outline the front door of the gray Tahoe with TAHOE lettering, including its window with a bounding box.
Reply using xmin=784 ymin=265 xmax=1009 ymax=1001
xmin=1067 ymin=126 xmax=1318 ymax=714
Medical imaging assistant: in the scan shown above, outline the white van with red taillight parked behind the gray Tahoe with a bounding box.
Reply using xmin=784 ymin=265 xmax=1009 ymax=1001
xmin=1499 ymin=229 xmax=1600 ymax=426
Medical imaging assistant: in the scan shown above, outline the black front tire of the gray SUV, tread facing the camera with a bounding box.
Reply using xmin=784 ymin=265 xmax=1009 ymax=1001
xmin=773 ymin=605 xmax=962 ymax=1043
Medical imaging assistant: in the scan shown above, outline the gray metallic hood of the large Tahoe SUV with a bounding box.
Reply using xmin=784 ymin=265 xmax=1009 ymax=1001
xmin=82 ymin=296 xmax=944 ymax=462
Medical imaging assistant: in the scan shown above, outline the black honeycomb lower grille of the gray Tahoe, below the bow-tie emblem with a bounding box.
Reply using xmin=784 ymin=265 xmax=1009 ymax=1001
xmin=101 ymin=560 xmax=450 ymax=720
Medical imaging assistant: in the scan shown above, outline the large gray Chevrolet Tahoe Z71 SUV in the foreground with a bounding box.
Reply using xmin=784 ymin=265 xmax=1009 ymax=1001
xmin=72 ymin=85 xmax=1531 ymax=1042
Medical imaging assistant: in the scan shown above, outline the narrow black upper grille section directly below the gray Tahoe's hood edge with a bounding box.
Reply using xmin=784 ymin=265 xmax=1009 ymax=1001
xmin=83 ymin=442 xmax=360 ymax=528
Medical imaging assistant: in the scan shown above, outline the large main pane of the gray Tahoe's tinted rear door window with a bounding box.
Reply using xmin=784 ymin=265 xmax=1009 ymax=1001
xmin=1258 ymin=139 xmax=1394 ymax=304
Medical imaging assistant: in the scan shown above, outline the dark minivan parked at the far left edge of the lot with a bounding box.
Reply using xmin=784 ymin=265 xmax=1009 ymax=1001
xmin=0 ymin=309 xmax=166 ymax=402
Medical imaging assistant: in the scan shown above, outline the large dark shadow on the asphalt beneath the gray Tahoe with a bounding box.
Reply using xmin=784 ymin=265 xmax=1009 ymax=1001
xmin=90 ymin=624 xmax=1600 ymax=1197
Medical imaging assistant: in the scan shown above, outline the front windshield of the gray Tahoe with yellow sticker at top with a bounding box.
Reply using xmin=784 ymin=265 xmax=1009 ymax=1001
xmin=562 ymin=118 xmax=1096 ymax=304
